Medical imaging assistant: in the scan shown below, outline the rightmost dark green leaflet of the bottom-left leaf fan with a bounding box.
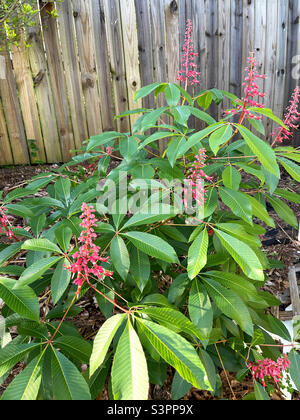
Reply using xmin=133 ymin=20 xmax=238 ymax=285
xmin=51 ymin=348 xmax=91 ymax=401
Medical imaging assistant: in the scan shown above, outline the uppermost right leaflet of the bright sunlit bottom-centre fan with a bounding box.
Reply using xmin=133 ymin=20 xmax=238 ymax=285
xmin=142 ymin=308 xmax=205 ymax=340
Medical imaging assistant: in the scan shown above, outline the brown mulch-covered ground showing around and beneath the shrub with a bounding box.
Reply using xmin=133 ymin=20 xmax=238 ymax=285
xmin=0 ymin=165 xmax=300 ymax=400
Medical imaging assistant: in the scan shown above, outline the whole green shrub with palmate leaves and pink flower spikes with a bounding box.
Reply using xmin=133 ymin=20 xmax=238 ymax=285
xmin=0 ymin=19 xmax=300 ymax=400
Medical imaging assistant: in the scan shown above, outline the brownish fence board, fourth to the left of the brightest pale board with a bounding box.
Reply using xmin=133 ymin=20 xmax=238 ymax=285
xmin=56 ymin=1 xmax=88 ymax=149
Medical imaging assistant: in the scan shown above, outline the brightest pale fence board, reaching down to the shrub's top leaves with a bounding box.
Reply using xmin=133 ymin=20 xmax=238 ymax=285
xmin=120 ymin=0 xmax=142 ymax=127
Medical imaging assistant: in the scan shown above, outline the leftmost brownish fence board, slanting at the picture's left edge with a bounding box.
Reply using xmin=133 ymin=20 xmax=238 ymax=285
xmin=0 ymin=52 xmax=30 ymax=164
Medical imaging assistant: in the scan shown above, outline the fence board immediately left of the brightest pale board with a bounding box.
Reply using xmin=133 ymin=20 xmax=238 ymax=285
xmin=103 ymin=0 xmax=130 ymax=132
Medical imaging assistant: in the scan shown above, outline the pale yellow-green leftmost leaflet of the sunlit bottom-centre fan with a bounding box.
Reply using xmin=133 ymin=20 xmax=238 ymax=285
xmin=90 ymin=314 xmax=125 ymax=376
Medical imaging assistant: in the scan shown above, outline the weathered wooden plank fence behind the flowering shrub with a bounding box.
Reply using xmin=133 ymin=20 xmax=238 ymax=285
xmin=0 ymin=0 xmax=300 ymax=165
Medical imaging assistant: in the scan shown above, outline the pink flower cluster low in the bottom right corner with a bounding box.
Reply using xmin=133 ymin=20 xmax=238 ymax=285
xmin=248 ymin=354 xmax=290 ymax=387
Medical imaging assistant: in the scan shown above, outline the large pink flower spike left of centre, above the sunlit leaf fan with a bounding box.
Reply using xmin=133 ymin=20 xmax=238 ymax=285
xmin=66 ymin=203 xmax=113 ymax=296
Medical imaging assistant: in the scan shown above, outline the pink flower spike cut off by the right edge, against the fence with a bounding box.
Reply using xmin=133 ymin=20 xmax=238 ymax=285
xmin=272 ymin=86 xmax=300 ymax=143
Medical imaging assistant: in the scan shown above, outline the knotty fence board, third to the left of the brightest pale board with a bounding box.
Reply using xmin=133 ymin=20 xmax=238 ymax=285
xmin=73 ymin=0 xmax=102 ymax=137
